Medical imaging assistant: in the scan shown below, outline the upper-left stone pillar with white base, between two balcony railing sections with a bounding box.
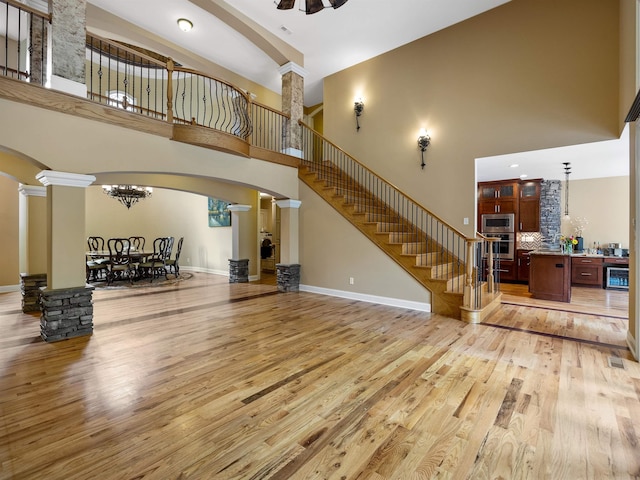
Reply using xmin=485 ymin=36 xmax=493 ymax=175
xmin=49 ymin=0 xmax=87 ymax=98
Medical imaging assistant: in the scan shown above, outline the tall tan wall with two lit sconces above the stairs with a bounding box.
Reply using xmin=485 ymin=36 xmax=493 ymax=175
xmin=324 ymin=0 xmax=621 ymax=236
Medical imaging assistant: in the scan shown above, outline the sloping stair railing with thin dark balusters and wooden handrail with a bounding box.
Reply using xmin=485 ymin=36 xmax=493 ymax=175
xmin=300 ymin=122 xmax=500 ymax=309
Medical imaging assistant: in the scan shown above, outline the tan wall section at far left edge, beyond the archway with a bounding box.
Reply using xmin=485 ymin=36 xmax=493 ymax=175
xmin=0 ymin=174 xmax=20 ymax=289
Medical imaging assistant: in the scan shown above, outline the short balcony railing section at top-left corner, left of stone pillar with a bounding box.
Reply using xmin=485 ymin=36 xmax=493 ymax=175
xmin=0 ymin=0 xmax=51 ymax=85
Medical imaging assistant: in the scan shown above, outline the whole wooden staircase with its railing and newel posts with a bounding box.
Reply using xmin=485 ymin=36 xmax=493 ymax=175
xmin=298 ymin=123 xmax=501 ymax=323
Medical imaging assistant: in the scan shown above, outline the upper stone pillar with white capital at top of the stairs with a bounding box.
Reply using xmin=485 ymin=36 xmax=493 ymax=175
xmin=278 ymin=62 xmax=306 ymax=158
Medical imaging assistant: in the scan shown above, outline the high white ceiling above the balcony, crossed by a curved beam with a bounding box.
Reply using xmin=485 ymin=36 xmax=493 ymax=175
xmin=88 ymin=0 xmax=509 ymax=106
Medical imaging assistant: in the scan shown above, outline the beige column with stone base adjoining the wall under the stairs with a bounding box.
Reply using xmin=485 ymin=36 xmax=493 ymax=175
xmin=276 ymin=199 xmax=302 ymax=292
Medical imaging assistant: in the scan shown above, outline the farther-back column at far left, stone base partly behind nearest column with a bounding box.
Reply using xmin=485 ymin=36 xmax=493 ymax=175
xmin=18 ymin=184 xmax=47 ymax=313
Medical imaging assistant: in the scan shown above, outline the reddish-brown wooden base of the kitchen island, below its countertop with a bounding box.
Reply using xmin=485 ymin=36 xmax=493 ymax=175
xmin=529 ymin=251 xmax=571 ymax=302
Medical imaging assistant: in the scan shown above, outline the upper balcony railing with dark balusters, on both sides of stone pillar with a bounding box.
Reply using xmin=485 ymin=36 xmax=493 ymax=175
xmin=0 ymin=4 xmax=289 ymax=153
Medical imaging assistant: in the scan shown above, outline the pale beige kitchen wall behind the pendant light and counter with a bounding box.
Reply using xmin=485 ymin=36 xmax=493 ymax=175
xmin=562 ymin=177 xmax=629 ymax=248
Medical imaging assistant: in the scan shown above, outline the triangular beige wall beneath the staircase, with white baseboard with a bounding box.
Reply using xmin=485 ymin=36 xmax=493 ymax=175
xmin=300 ymin=183 xmax=431 ymax=304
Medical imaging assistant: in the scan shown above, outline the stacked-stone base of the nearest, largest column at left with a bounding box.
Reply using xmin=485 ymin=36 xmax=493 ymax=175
xmin=40 ymin=285 xmax=93 ymax=342
